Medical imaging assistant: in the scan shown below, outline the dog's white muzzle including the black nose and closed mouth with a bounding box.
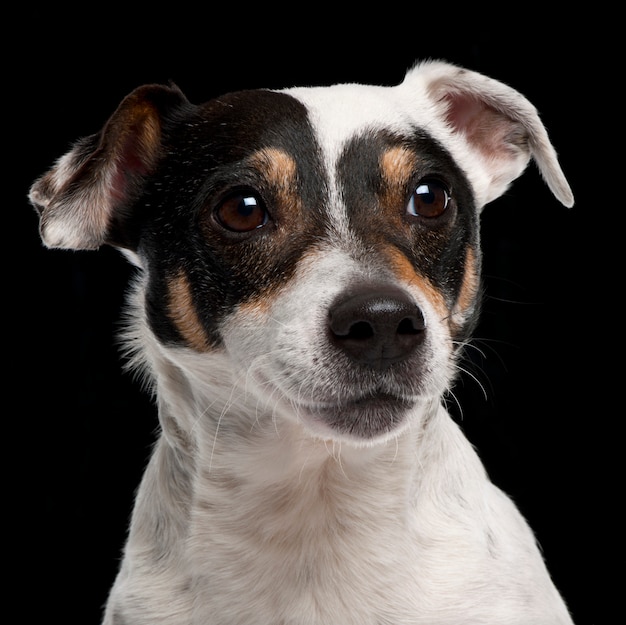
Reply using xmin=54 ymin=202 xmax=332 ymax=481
xmin=229 ymin=280 xmax=434 ymax=442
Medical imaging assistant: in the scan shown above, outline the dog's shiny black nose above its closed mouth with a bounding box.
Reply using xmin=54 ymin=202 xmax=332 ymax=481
xmin=328 ymin=285 xmax=425 ymax=370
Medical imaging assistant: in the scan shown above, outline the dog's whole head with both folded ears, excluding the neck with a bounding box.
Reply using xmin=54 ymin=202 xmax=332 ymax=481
xmin=30 ymin=62 xmax=572 ymax=442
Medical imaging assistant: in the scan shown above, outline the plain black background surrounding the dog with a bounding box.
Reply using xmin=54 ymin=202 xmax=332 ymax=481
xmin=13 ymin=5 xmax=608 ymax=625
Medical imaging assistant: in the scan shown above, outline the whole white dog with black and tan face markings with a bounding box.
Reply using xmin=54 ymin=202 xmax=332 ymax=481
xmin=29 ymin=60 xmax=573 ymax=625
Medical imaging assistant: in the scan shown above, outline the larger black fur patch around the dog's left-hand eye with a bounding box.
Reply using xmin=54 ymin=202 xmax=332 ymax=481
xmin=132 ymin=91 xmax=327 ymax=344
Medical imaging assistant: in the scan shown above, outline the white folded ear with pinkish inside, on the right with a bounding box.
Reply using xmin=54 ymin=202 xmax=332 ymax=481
xmin=403 ymin=61 xmax=574 ymax=207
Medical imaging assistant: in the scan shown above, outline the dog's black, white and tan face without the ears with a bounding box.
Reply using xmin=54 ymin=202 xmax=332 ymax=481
xmin=139 ymin=86 xmax=478 ymax=439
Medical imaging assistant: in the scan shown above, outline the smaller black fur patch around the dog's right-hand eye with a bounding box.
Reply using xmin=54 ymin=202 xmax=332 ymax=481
xmin=338 ymin=129 xmax=479 ymax=338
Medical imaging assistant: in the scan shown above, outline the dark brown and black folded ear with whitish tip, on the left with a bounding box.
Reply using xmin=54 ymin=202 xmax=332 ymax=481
xmin=29 ymin=85 xmax=189 ymax=250
